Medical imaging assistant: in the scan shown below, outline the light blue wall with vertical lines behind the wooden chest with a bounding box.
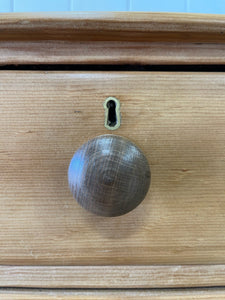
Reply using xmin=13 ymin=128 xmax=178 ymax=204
xmin=0 ymin=0 xmax=225 ymax=14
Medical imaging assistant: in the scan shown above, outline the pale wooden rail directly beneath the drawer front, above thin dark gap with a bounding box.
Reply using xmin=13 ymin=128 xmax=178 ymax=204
xmin=0 ymin=265 xmax=225 ymax=289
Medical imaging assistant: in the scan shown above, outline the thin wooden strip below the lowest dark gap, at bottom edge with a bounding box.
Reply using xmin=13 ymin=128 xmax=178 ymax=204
xmin=0 ymin=288 xmax=225 ymax=300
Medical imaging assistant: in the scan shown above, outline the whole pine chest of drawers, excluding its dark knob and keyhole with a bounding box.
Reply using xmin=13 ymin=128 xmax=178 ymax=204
xmin=0 ymin=13 xmax=225 ymax=299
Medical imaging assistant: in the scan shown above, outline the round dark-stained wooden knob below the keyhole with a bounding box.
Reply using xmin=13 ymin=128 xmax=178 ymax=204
xmin=68 ymin=135 xmax=151 ymax=217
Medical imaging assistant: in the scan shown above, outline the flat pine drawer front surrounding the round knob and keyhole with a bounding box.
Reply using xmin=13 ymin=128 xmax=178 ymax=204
xmin=0 ymin=71 xmax=225 ymax=265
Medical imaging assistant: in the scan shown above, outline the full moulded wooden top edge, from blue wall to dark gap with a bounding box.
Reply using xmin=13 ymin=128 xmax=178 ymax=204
xmin=0 ymin=12 xmax=225 ymax=65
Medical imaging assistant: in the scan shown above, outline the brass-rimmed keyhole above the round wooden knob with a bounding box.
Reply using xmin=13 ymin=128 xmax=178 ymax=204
xmin=104 ymin=97 xmax=120 ymax=130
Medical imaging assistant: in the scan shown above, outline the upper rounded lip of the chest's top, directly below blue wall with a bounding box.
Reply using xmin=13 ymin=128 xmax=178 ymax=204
xmin=0 ymin=12 xmax=225 ymax=43
